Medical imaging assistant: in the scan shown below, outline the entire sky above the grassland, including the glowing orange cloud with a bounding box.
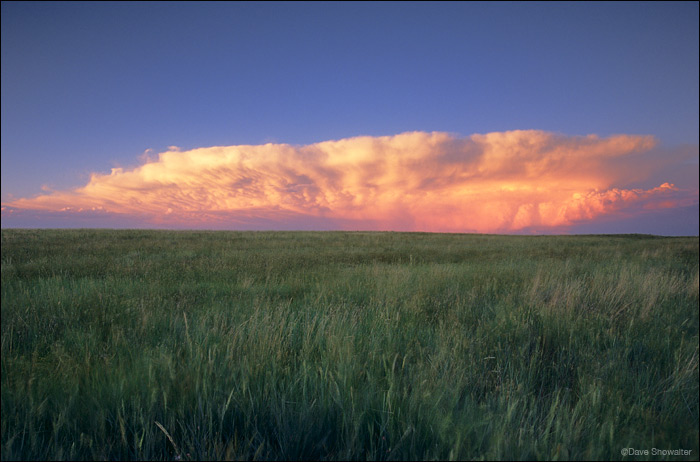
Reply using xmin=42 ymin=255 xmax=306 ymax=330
xmin=0 ymin=1 xmax=700 ymax=235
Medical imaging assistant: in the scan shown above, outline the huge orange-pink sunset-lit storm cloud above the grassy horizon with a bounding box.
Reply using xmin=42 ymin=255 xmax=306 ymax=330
xmin=2 ymin=130 xmax=698 ymax=233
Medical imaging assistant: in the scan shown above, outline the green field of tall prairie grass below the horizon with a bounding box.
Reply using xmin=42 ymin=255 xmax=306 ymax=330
xmin=1 ymin=229 xmax=699 ymax=460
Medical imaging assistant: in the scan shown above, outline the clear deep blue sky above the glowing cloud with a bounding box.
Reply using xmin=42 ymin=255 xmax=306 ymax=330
xmin=1 ymin=2 xmax=699 ymax=233
